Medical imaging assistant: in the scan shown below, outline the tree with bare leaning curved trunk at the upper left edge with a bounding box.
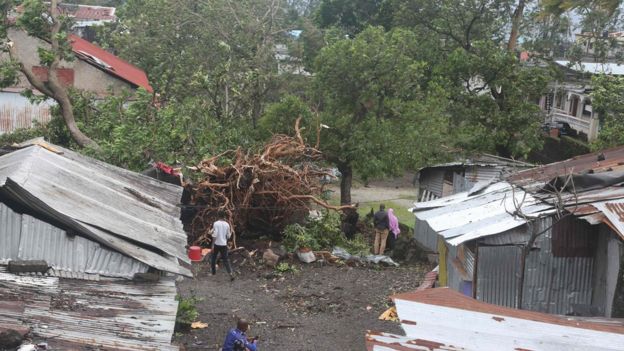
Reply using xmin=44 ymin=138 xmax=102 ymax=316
xmin=1 ymin=0 xmax=98 ymax=148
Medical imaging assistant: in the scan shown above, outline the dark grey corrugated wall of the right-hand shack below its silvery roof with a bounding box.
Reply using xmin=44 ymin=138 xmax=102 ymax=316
xmin=475 ymin=218 xmax=607 ymax=315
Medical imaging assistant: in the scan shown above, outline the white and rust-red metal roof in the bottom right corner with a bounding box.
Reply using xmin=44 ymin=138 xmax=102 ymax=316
xmin=366 ymin=288 xmax=624 ymax=351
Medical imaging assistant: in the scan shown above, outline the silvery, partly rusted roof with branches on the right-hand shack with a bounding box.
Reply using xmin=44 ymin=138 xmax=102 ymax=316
xmin=412 ymin=147 xmax=624 ymax=245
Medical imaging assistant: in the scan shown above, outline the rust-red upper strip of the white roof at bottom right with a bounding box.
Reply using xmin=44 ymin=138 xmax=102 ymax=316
xmin=391 ymin=288 xmax=624 ymax=334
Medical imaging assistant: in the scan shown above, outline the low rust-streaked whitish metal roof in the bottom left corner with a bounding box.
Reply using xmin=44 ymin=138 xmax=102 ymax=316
xmin=0 ymin=269 xmax=178 ymax=351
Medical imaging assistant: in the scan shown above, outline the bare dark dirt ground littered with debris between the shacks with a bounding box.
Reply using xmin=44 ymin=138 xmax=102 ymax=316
xmin=175 ymin=254 xmax=431 ymax=351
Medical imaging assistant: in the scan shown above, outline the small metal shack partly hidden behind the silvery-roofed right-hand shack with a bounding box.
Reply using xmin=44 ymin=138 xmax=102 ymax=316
xmin=414 ymin=154 xmax=534 ymax=252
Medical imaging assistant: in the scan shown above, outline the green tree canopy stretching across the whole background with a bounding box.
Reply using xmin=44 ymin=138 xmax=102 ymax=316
xmin=0 ymin=0 xmax=624 ymax=203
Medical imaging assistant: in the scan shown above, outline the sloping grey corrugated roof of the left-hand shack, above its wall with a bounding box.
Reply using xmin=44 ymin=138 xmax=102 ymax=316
xmin=0 ymin=144 xmax=191 ymax=276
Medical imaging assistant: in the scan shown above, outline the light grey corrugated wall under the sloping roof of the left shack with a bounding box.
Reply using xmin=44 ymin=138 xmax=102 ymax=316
xmin=0 ymin=203 xmax=149 ymax=278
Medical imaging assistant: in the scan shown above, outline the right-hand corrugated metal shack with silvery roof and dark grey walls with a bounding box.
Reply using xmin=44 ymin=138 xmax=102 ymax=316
xmin=414 ymin=148 xmax=624 ymax=317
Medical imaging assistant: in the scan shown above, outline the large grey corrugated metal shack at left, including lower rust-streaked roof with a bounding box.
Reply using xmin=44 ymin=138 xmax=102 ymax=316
xmin=0 ymin=140 xmax=191 ymax=350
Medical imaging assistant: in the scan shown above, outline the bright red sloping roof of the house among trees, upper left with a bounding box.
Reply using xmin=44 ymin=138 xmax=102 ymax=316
xmin=69 ymin=34 xmax=154 ymax=92
